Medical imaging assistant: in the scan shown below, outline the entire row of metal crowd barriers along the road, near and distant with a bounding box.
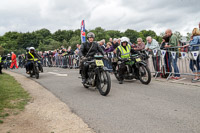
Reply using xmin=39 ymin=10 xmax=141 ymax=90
xmin=39 ymin=45 xmax=200 ymax=80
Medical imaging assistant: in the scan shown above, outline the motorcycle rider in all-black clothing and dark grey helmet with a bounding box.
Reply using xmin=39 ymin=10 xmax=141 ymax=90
xmin=79 ymin=32 xmax=105 ymax=84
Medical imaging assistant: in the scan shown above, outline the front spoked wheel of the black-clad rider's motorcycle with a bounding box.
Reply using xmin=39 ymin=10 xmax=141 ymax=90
xmin=97 ymin=70 xmax=111 ymax=96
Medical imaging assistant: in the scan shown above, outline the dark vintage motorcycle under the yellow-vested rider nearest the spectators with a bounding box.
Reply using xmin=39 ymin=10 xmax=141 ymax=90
xmin=113 ymin=54 xmax=151 ymax=85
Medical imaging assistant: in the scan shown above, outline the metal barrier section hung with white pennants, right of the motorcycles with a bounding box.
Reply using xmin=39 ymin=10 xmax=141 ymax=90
xmin=148 ymin=45 xmax=200 ymax=80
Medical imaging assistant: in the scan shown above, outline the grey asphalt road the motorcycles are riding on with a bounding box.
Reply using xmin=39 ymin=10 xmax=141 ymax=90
xmin=12 ymin=68 xmax=200 ymax=133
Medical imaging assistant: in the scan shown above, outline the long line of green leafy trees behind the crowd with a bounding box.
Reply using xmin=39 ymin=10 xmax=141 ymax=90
xmin=0 ymin=27 xmax=165 ymax=54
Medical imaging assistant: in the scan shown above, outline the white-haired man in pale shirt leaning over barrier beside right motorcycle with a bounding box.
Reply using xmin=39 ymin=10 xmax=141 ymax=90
xmin=145 ymin=36 xmax=160 ymax=77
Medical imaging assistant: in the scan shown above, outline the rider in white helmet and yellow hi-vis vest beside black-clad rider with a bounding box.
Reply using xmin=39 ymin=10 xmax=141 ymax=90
xmin=116 ymin=37 xmax=136 ymax=84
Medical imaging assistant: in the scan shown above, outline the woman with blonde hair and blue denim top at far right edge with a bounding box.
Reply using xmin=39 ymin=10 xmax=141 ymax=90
xmin=184 ymin=28 xmax=200 ymax=82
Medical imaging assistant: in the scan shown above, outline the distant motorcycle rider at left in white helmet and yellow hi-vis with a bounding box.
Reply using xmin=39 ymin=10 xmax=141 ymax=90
xmin=26 ymin=47 xmax=39 ymax=74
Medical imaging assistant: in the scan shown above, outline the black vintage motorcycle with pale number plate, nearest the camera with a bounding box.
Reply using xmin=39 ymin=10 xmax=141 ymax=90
xmin=80 ymin=55 xmax=111 ymax=96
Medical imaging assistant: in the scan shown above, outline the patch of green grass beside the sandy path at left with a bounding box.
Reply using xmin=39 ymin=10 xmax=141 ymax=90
xmin=0 ymin=73 xmax=30 ymax=123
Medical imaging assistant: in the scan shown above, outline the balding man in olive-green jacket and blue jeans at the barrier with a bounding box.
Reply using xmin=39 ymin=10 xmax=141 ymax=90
xmin=165 ymin=29 xmax=180 ymax=80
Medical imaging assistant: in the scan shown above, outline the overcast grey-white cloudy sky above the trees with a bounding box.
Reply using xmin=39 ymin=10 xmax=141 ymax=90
xmin=0 ymin=0 xmax=200 ymax=35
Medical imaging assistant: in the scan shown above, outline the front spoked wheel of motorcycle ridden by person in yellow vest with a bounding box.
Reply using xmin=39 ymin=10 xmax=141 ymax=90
xmin=139 ymin=65 xmax=151 ymax=85
